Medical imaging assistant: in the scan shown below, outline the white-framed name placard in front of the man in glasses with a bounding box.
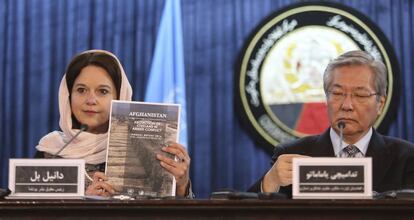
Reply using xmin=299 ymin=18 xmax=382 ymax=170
xmin=292 ymin=157 xmax=372 ymax=199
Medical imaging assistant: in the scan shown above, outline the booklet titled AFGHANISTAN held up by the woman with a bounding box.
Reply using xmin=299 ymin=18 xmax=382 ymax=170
xmin=106 ymin=100 xmax=180 ymax=197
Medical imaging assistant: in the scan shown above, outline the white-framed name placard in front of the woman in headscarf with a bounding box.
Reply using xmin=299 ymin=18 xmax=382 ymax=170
xmin=9 ymin=159 xmax=85 ymax=198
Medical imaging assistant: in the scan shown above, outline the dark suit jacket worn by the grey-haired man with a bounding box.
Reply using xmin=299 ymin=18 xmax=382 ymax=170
xmin=248 ymin=129 xmax=414 ymax=197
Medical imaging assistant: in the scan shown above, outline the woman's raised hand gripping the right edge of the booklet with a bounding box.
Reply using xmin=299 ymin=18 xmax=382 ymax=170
xmin=157 ymin=143 xmax=191 ymax=197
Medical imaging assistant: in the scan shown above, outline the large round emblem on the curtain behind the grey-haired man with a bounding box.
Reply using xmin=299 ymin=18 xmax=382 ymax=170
xmin=236 ymin=2 xmax=398 ymax=151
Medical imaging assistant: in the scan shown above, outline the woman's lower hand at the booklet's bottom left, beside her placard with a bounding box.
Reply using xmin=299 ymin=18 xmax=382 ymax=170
xmin=85 ymin=172 xmax=115 ymax=197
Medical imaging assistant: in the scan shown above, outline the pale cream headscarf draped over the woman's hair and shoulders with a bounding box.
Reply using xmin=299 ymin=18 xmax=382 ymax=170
xmin=36 ymin=50 xmax=132 ymax=164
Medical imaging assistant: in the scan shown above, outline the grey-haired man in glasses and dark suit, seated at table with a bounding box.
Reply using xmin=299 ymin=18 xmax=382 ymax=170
xmin=249 ymin=51 xmax=414 ymax=196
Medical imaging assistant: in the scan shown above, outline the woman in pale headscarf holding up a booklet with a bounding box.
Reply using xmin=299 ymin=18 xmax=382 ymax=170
xmin=36 ymin=50 xmax=193 ymax=197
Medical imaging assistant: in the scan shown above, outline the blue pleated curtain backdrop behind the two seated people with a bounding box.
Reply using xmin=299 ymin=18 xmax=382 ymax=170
xmin=0 ymin=0 xmax=414 ymax=198
